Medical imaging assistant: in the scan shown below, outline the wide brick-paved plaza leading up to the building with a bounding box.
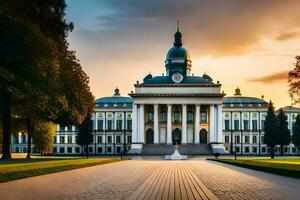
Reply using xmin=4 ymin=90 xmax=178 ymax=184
xmin=0 ymin=157 xmax=300 ymax=200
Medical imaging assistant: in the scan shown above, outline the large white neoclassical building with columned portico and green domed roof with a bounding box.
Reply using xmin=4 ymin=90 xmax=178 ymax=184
xmin=12 ymin=27 xmax=300 ymax=155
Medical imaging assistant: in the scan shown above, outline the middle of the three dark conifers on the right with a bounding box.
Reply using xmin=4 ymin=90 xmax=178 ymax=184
xmin=276 ymin=108 xmax=291 ymax=156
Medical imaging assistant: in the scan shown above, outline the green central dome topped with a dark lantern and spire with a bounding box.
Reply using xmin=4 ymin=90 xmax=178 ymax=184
xmin=165 ymin=23 xmax=192 ymax=76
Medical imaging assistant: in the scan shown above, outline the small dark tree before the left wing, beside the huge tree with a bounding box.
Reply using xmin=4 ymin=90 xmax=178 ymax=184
xmin=76 ymin=116 xmax=93 ymax=157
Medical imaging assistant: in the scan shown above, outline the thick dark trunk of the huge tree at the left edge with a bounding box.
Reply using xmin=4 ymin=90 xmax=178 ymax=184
xmin=0 ymin=94 xmax=11 ymax=160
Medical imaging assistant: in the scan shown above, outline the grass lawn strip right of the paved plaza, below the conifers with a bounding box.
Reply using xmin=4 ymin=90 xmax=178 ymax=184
xmin=211 ymin=158 xmax=300 ymax=178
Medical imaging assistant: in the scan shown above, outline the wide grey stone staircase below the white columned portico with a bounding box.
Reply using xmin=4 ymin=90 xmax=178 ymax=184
xmin=141 ymin=144 xmax=212 ymax=155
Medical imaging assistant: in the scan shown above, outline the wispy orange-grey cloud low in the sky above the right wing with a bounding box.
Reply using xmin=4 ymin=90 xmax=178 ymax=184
xmin=247 ymin=70 xmax=289 ymax=84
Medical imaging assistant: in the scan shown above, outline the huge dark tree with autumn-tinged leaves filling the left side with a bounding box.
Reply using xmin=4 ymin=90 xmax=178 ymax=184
xmin=0 ymin=0 xmax=94 ymax=159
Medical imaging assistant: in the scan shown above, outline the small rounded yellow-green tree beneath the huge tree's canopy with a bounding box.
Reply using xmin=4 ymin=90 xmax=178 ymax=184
xmin=32 ymin=122 xmax=56 ymax=155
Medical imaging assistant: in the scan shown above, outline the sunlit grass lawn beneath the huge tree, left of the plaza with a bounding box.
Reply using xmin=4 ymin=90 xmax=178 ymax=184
xmin=0 ymin=156 xmax=120 ymax=183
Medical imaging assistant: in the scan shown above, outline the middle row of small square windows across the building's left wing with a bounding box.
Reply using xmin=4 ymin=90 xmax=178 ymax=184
xmin=54 ymin=135 xmax=131 ymax=144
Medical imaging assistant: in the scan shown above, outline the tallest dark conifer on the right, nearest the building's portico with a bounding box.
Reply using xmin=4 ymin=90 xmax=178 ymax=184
xmin=264 ymin=101 xmax=278 ymax=159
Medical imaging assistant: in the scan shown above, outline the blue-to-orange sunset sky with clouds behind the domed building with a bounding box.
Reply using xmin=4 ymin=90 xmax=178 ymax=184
xmin=66 ymin=0 xmax=300 ymax=107
